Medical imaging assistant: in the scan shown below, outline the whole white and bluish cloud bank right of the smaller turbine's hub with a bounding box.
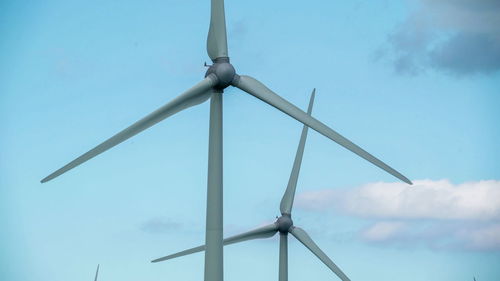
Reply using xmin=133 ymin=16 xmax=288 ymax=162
xmin=297 ymin=180 xmax=500 ymax=251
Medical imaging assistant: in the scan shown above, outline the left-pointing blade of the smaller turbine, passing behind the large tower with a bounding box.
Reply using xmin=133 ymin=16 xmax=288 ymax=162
xmin=151 ymin=223 xmax=278 ymax=262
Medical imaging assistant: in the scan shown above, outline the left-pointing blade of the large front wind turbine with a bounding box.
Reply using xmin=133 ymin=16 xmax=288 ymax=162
xmin=41 ymin=76 xmax=217 ymax=183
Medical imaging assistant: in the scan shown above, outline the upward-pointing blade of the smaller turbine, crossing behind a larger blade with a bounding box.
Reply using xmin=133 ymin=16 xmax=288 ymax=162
xmin=280 ymin=89 xmax=316 ymax=215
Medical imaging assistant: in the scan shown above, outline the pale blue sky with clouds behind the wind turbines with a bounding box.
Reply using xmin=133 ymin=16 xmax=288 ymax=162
xmin=0 ymin=0 xmax=500 ymax=281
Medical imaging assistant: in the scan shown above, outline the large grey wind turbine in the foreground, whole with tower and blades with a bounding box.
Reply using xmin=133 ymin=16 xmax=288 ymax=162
xmin=41 ymin=0 xmax=411 ymax=281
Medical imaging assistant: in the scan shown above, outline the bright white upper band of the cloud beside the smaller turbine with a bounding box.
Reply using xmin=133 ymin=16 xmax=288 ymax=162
xmin=297 ymin=180 xmax=500 ymax=220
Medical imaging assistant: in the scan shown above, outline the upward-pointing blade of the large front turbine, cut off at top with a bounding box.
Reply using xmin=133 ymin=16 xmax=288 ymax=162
xmin=207 ymin=0 xmax=228 ymax=61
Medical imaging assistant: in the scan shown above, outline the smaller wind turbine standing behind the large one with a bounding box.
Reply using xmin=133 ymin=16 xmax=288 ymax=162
xmin=152 ymin=89 xmax=350 ymax=281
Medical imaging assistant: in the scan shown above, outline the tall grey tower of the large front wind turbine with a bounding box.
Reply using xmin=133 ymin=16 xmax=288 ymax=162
xmin=205 ymin=91 xmax=224 ymax=281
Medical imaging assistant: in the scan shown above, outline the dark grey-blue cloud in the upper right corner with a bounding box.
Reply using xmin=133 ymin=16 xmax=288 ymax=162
xmin=376 ymin=0 xmax=500 ymax=75
